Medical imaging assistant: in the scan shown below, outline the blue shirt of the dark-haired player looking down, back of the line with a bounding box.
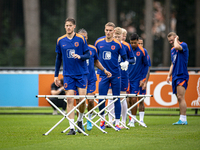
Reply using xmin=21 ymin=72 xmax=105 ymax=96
xmin=128 ymin=44 xmax=149 ymax=81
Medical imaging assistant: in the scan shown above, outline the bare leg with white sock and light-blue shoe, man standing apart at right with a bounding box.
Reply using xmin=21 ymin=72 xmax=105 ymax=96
xmin=174 ymin=80 xmax=188 ymax=125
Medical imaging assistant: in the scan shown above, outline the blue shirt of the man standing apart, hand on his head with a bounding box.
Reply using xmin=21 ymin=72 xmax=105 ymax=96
xmin=171 ymin=42 xmax=189 ymax=81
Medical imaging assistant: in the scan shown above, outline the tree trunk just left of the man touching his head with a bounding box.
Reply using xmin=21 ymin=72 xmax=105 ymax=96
xmin=163 ymin=0 xmax=171 ymax=67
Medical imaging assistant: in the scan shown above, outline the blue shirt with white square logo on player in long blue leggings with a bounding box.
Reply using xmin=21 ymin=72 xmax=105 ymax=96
xmin=95 ymin=38 xmax=126 ymax=76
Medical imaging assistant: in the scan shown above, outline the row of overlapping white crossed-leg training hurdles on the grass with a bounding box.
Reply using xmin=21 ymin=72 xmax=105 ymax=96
xmin=36 ymin=94 xmax=152 ymax=136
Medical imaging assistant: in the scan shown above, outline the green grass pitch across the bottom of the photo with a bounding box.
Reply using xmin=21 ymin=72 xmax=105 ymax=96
xmin=0 ymin=110 xmax=200 ymax=150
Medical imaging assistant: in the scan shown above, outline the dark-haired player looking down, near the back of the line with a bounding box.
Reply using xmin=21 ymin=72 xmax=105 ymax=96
xmin=128 ymin=33 xmax=149 ymax=127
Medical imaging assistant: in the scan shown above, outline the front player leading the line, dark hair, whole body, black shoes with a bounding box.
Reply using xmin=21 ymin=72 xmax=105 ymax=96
xmin=54 ymin=18 xmax=90 ymax=135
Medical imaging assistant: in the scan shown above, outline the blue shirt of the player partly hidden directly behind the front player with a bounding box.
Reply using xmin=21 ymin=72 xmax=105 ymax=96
xmin=86 ymin=44 xmax=98 ymax=82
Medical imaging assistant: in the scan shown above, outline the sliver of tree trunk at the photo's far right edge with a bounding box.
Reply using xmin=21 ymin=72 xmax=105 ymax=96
xmin=195 ymin=0 xmax=200 ymax=67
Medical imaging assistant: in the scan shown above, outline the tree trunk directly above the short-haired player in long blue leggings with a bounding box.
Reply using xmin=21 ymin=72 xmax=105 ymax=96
xmin=108 ymin=0 xmax=117 ymax=26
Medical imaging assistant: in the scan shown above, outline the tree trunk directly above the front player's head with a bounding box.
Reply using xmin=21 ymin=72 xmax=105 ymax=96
xmin=67 ymin=0 xmax=76 ymax=20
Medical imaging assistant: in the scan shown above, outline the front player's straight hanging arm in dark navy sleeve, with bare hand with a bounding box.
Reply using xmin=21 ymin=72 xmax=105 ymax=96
xmin=54 ymin=53 xmax=62 ymax=86
